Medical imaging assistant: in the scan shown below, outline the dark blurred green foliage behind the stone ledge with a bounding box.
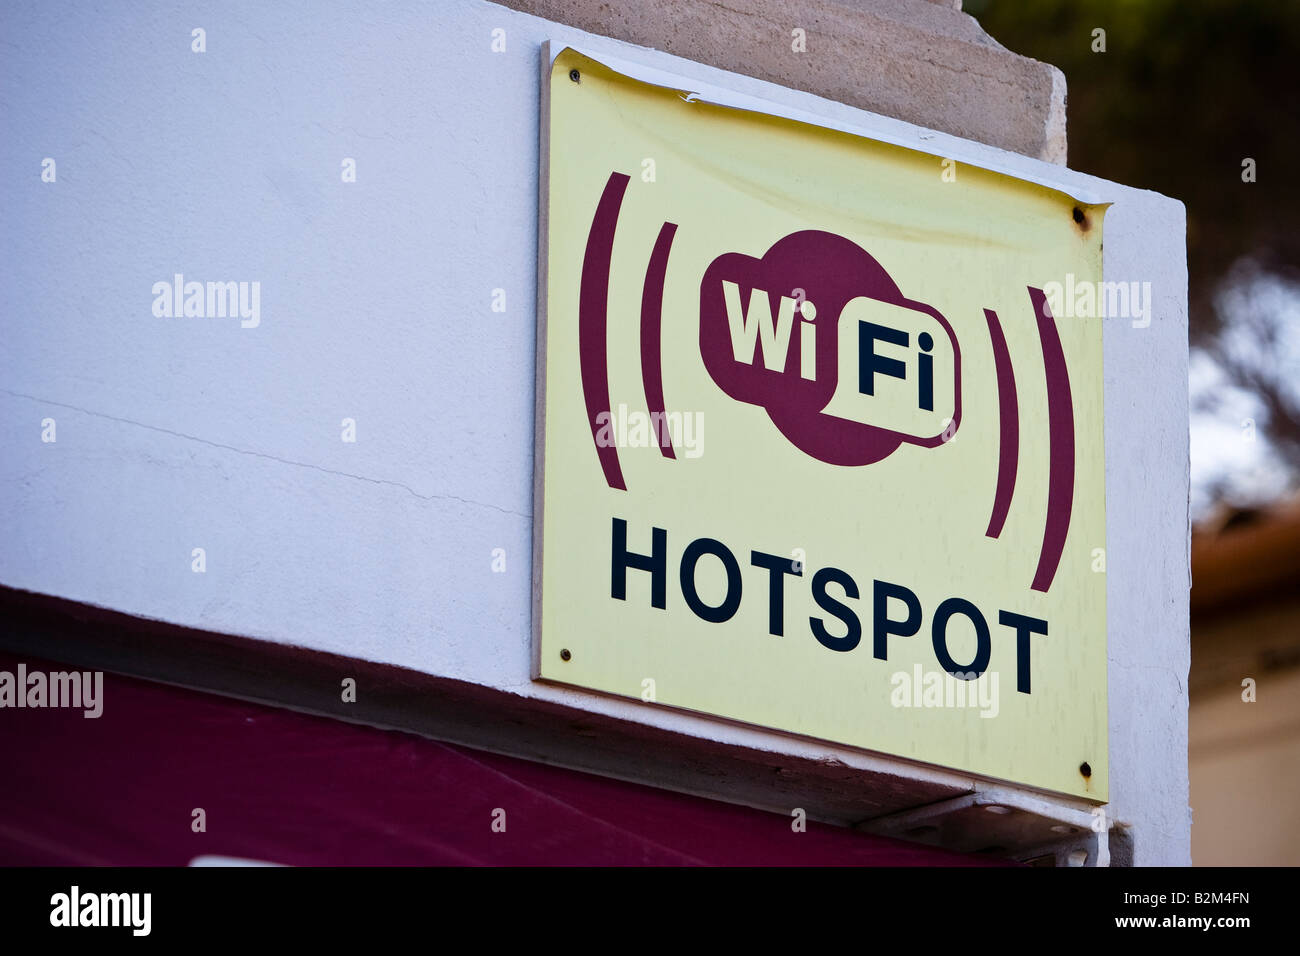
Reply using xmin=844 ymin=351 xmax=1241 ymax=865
xmin=963 ymin=0 xmax=1300 ymax=341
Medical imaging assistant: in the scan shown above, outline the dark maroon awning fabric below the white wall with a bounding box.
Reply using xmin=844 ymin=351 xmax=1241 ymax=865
xmin=0 ymin=654 xmax=1002 ymax=866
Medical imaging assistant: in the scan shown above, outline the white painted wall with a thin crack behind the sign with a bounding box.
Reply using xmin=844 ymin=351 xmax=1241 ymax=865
xmin=0 ymin=0 xmax=1190 ymax=864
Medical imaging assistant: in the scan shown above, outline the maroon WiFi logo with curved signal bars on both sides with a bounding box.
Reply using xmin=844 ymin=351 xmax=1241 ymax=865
xmin=579 ymin=172 xmax=1075 ymax=593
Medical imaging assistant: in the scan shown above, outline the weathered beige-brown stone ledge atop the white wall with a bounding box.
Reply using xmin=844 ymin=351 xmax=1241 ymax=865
xmin=495 ymin=0 xmax=1066 ymax=165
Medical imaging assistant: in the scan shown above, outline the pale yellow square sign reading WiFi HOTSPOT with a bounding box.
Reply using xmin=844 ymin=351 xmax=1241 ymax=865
xmin=534 ymin=49 xmax=1106 ymax=801
